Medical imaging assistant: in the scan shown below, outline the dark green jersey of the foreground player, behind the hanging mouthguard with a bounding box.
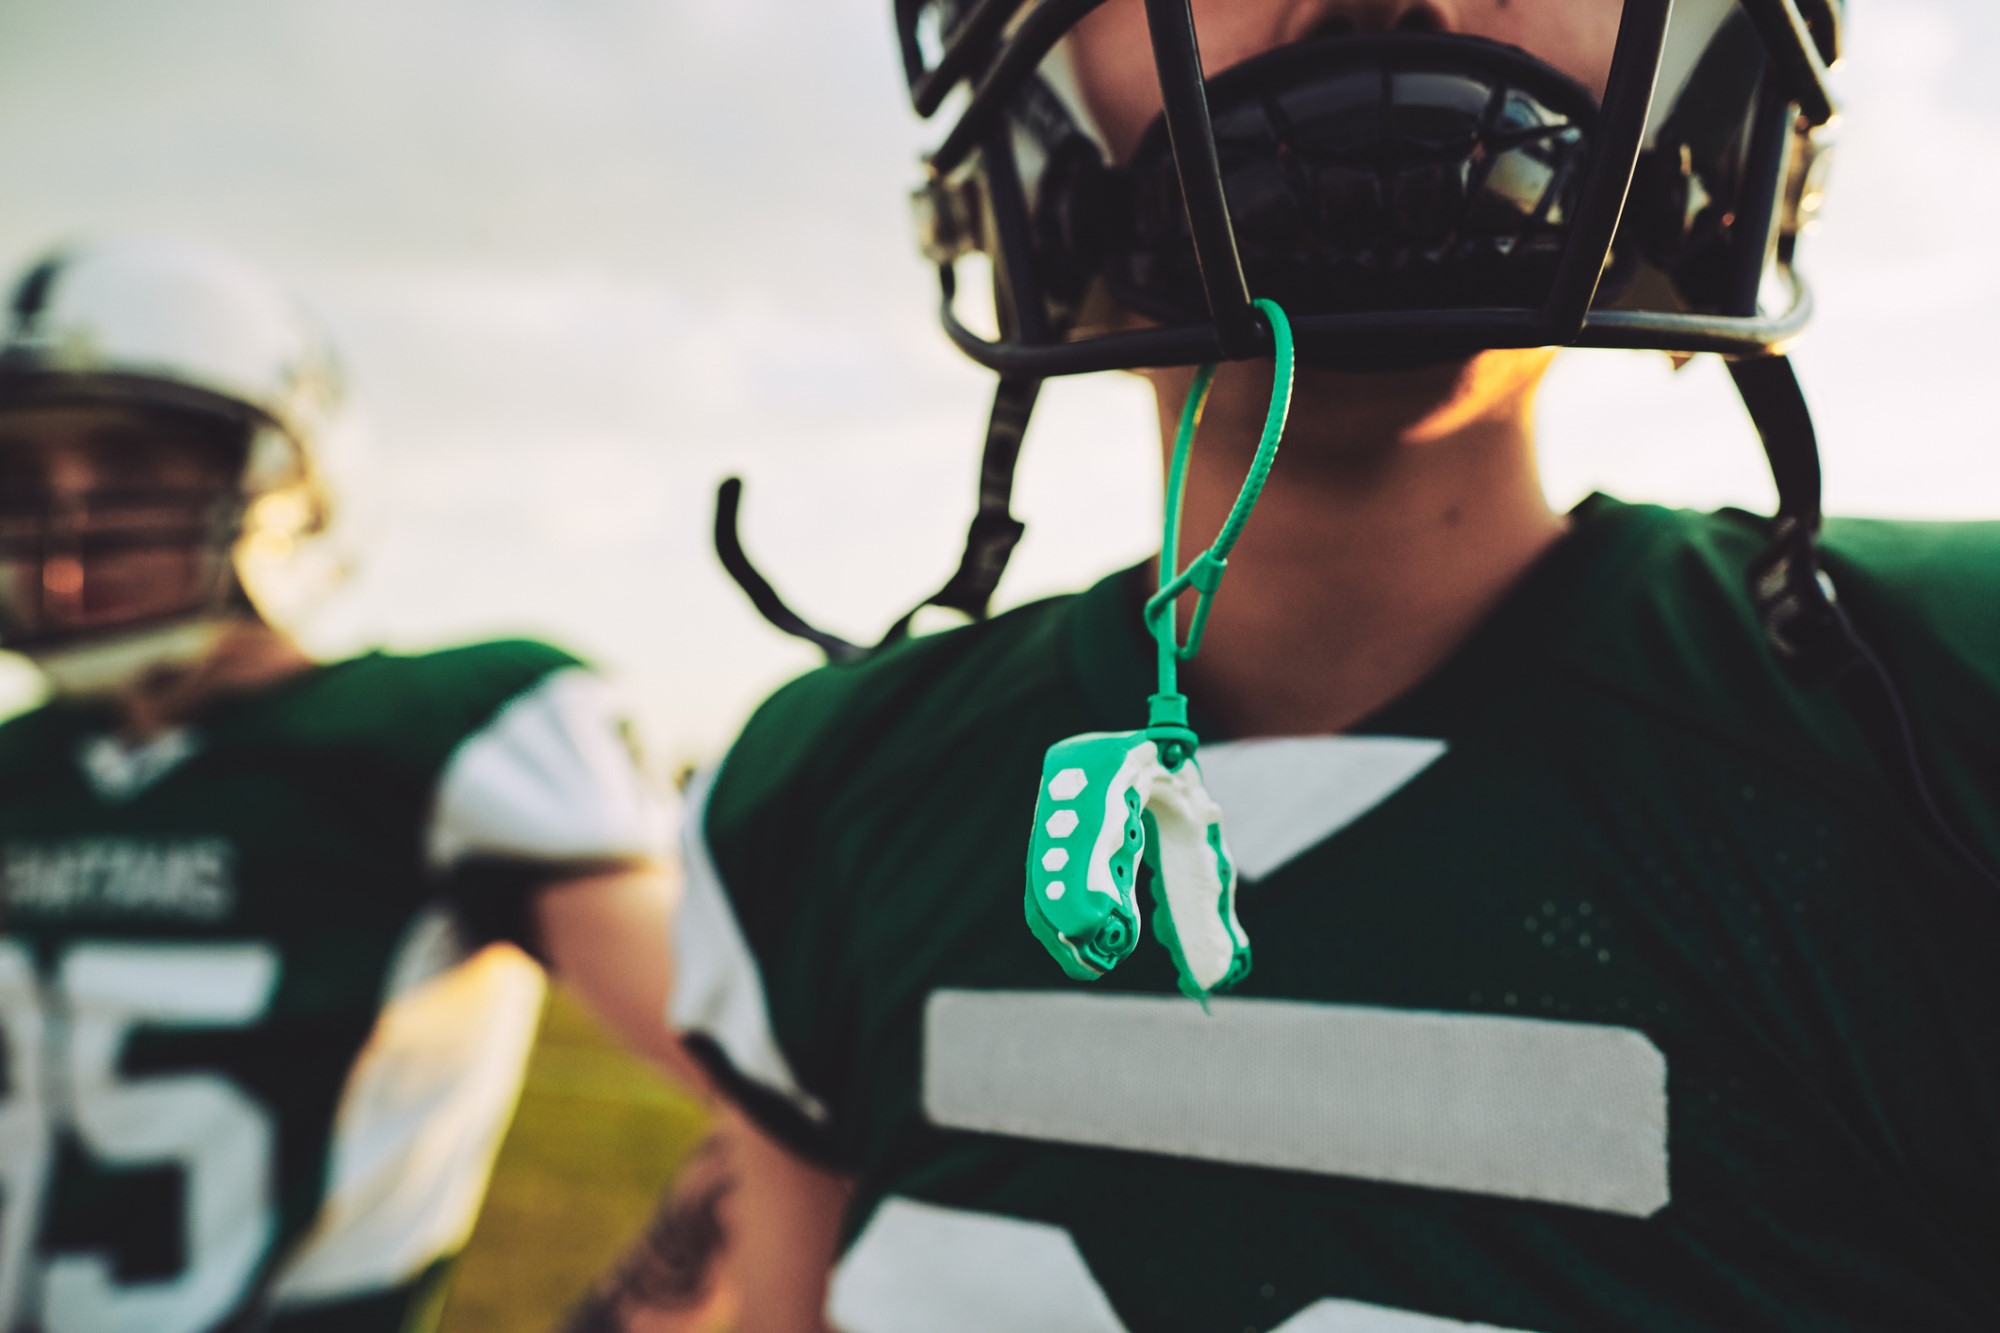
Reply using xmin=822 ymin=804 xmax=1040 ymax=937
xmin=676 ymin=498 xmax=2000 ymax=1333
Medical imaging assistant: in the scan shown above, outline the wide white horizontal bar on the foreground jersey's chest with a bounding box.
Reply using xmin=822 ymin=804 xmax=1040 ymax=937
xmin=924 ymin=991 xmax=1668 ymax=1217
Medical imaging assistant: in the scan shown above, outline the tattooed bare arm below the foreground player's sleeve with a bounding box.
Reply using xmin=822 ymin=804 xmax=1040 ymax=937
xmin=562 ymin=1107 xmax=852 ymax=1333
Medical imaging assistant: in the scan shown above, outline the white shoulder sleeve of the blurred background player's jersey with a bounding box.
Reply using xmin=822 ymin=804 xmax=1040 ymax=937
xmin=426 ymin=667 xmax=672 ymax=869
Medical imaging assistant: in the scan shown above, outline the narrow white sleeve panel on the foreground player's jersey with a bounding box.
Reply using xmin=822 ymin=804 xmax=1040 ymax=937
xmin=668 ymin=771 xmax=826 ymax=1121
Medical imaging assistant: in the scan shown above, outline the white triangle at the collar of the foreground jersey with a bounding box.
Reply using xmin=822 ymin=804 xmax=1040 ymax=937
xmin=1198 ymin=737 xmax=1446 ymax=879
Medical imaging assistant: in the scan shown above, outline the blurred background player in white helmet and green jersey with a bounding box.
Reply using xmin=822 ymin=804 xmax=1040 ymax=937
xmin=0 ymin=244 xmax=704 ymax=1333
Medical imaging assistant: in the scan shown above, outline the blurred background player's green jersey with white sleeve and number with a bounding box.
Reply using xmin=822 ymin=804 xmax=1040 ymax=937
xmin=0 ymin=642 xmax=662 ymax=1333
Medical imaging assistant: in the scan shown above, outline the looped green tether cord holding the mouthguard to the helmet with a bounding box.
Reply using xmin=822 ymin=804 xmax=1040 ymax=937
xmin=1146 ymin=300 xmax=1296 ymax=769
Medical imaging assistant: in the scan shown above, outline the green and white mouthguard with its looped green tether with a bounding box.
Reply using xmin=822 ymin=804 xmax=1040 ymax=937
xmin=1024 ymin=300 xmax=1294 ymax=1005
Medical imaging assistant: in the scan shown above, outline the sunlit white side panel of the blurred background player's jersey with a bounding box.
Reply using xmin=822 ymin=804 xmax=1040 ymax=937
xmin=270 ymin=909 xmax=546 ymax=1309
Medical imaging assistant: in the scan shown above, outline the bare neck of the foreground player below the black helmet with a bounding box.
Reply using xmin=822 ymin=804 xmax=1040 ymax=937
xmin=1162 ymin=358 xmax=1568 ymax=737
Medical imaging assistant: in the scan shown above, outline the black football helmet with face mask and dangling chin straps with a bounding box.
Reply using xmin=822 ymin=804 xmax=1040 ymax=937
xmin=718 ymin=0 xmax=1850 ymax=677
